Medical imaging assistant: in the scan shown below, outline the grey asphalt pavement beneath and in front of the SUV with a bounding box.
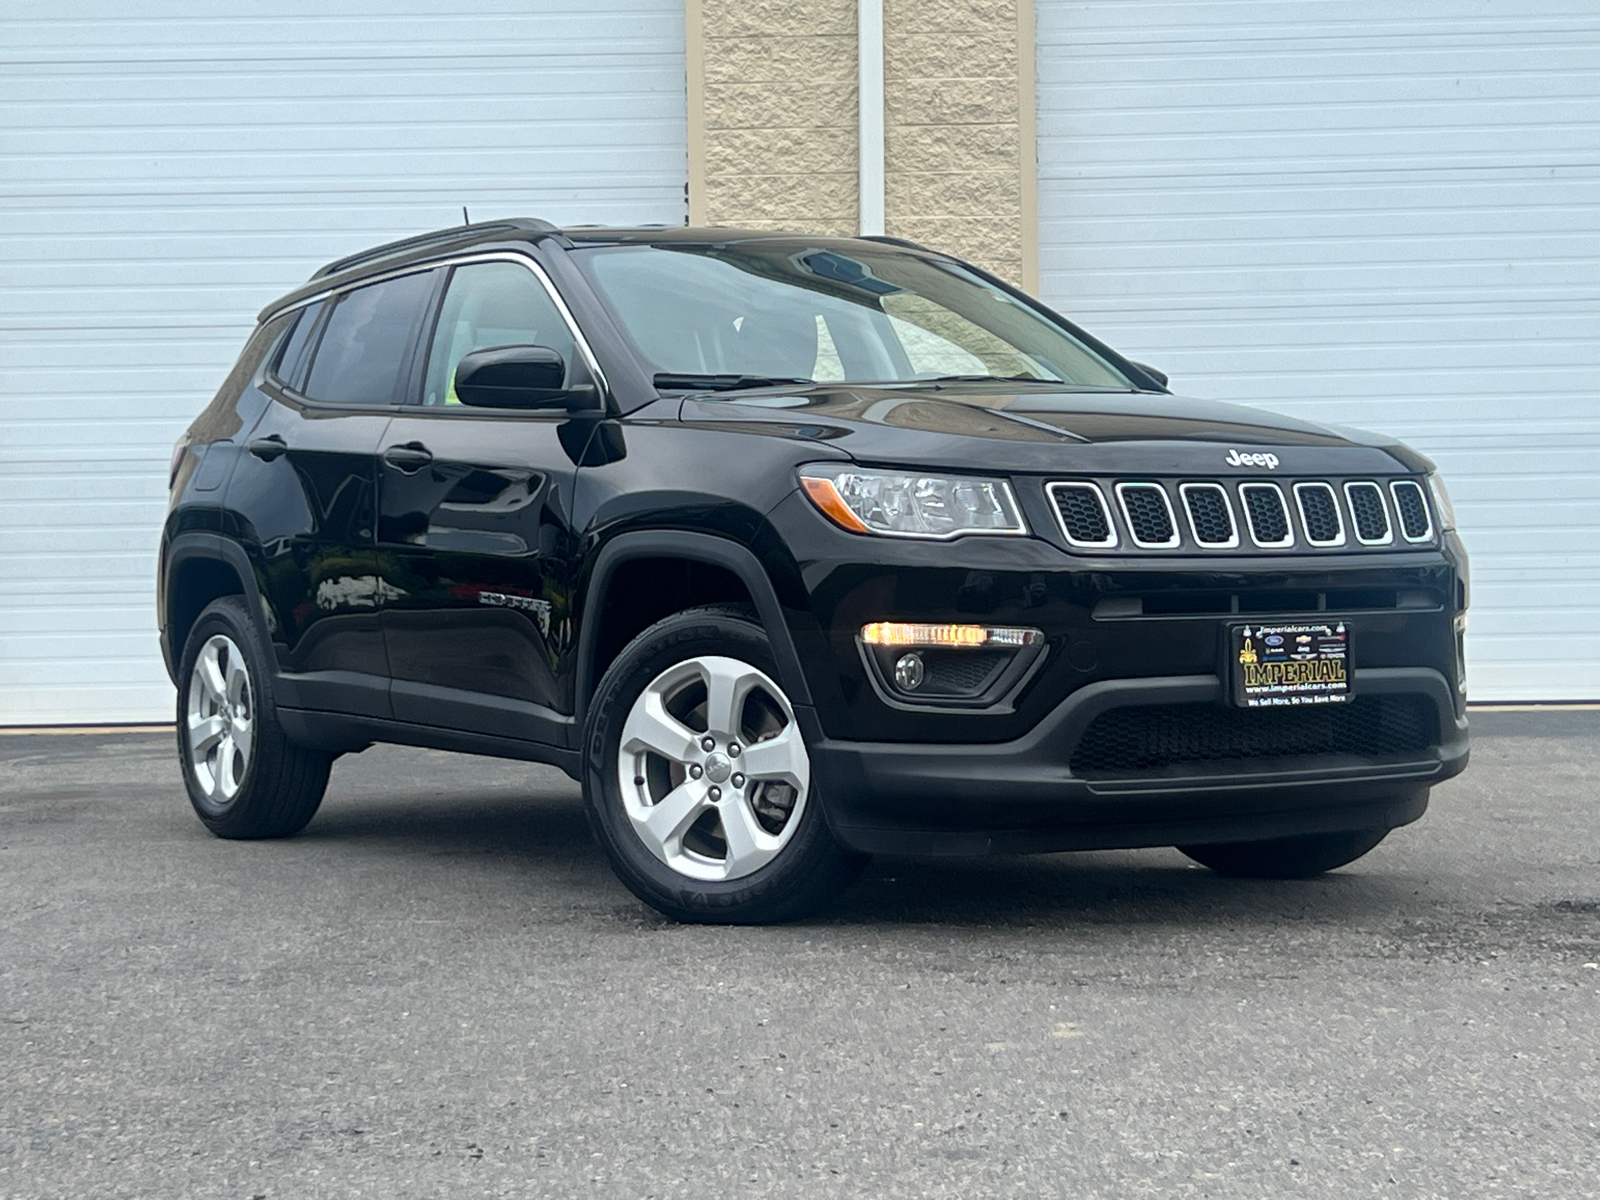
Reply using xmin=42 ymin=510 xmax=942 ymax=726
xmin=0 ymin=712 xmax=1600 ymax=1200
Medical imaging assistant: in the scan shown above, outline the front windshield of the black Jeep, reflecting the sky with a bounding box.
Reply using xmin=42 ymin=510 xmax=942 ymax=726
xmin=578 ymin=238 xmax=1133 ymax=392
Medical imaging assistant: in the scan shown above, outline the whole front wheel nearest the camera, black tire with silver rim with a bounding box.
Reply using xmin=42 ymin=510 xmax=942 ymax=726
xmin=584 ymin=605 xmax=866 ymax=923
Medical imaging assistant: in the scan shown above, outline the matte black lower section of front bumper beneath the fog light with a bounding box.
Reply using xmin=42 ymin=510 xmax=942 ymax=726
xmin=797 ymin=667 xmax=1467 ymax=854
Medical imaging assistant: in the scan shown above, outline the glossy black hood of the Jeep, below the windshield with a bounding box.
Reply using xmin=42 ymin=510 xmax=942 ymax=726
xmin=682 ymin=387 xmax=1430 ymax=475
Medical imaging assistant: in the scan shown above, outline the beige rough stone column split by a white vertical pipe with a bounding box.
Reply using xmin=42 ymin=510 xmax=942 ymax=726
xmin=685 ymin=0 xmax=1038 ymax=290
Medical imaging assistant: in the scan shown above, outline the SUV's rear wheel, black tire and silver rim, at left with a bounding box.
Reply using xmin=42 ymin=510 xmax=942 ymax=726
xmin=178 ymin=595 xmax=333 ymax=838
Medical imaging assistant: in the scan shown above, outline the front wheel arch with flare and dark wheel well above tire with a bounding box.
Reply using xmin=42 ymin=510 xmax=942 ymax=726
xmin=574 ymin=530 xmax=811 ymax=728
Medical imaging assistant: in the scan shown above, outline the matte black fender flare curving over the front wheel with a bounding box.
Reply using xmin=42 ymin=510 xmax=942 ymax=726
xmin=573 ymin=530 xmax=811 ymax=736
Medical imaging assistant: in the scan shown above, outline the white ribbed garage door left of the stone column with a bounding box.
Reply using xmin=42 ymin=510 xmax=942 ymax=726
xmin=0 ymin=0 xmax=686 ymax=725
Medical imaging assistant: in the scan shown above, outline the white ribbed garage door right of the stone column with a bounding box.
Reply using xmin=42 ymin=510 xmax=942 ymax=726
xmin=1038 ymin=0 xmax=1600 ymax=699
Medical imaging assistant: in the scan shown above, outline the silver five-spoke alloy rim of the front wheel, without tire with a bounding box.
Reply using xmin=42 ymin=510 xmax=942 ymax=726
xmin=616 ymin=656 xmax=811 ymax=880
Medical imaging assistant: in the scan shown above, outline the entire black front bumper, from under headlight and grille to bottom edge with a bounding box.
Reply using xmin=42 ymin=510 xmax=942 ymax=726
xmin=773 ymin=490 xmax=1467 ymax=854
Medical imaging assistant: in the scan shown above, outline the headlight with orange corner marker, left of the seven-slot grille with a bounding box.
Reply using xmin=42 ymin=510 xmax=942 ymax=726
xmin=800 ymin=466 xmax=1027 ymax=538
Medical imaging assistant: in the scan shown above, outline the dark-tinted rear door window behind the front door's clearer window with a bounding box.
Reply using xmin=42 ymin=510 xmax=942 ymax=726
xmin=301 ymin=272 xmax=434 ymax=405
